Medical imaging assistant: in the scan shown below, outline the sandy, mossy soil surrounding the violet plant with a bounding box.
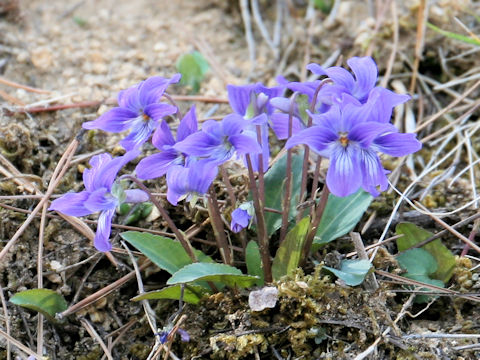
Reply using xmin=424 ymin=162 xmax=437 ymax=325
xmin=0 ymin=0 xmax=480 ymax=360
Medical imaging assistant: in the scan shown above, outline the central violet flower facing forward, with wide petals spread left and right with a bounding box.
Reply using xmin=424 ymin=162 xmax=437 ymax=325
xmin=173 ymin=114 xmax=262 ymax=165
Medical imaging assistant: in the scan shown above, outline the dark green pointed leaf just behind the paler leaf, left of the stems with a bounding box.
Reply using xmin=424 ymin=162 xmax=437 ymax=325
xmin=120 ymin=231 xmax=213 ymax=274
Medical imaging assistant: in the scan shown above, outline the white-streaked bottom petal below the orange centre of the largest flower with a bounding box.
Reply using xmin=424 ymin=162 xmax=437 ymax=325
xmin=327 ymin=145 xmax=362 ymax=197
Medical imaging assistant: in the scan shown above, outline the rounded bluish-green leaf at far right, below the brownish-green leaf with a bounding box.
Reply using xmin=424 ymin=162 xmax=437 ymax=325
xmin=397 ymin=249 xmax=444 ymax=303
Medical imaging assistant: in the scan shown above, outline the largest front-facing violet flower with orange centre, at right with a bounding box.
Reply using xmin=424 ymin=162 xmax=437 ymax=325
xmin=286 ymin=100 xmax=422 ymax=197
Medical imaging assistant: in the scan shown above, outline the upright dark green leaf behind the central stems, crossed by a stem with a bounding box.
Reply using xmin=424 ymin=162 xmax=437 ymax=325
xmin=265 ymin=151 xmax=303 ymax=237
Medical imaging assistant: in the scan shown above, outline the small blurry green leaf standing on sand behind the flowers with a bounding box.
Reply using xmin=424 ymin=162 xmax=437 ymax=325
xmin=176 ymin=51 xmax=209 ymax=93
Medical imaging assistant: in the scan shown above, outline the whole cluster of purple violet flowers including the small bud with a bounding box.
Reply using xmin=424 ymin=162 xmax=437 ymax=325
xmin=50 ymin=57 xmax=421 ymax=251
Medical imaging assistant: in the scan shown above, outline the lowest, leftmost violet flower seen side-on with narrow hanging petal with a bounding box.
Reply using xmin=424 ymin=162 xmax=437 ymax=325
xmin=49 ymin=150 xmax=148 ymax=252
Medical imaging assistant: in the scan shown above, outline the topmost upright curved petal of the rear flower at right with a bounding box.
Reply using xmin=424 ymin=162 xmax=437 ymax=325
xmin=347 ymin=56 xmax=378 ymax=101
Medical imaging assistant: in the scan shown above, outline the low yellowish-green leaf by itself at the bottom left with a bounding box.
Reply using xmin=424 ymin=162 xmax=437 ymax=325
xmin=10 ymin=289 xmax=68 ymax=321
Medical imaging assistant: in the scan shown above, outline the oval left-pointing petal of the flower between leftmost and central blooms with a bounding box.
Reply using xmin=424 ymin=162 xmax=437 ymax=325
xmin=135 ymin=149 xmax=183 ymax=180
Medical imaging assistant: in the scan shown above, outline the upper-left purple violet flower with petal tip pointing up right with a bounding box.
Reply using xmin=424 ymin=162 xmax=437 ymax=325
xmin=83 ymin=74 xmax=181 ymax=151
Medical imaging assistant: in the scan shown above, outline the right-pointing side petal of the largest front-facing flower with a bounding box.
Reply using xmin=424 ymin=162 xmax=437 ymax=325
xmin=372 ymin=133 xmax=422 ymax=156
